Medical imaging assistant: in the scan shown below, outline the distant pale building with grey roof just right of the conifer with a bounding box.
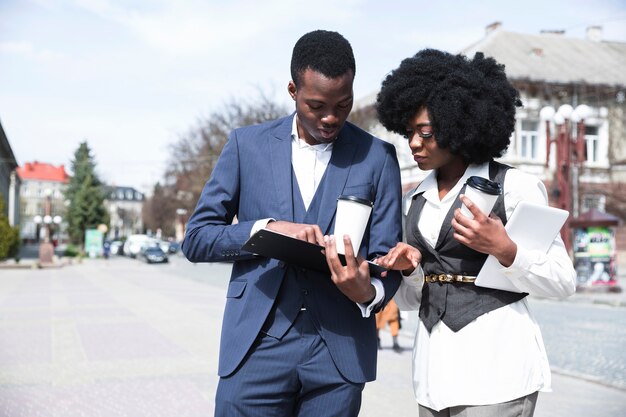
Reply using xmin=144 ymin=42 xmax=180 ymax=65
xmin=104 ymin=186 xmax=145 ymax=240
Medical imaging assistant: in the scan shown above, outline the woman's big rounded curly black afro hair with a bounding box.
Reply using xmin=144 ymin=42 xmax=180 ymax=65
xmin=376 ymin=49 xmax=522 ymax=164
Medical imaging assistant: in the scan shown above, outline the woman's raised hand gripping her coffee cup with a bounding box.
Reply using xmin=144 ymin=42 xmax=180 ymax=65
xmin=451 ymin=194 xmax=517 ymax=267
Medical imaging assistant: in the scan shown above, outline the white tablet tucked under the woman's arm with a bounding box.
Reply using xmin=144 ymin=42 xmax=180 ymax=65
xmin=474 ymin=201 xmax=569 ymax=292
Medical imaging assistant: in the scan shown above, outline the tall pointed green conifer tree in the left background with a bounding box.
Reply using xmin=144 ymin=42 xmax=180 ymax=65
xmin=65 ymin=142 xmax=109 ymax=244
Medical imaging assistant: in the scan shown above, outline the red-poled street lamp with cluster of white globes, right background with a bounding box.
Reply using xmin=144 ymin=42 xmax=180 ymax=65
xmin=539 ymin=104 xmax=591 ymax=251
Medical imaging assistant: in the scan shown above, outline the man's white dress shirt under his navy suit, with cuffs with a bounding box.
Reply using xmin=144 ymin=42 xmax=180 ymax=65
xmin=250 ymin=115 xmax=385 ymax=318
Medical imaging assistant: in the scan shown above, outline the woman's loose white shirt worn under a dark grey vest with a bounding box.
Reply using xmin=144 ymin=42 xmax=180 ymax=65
xmin=394 ymin=163 xmax=576 ymax=411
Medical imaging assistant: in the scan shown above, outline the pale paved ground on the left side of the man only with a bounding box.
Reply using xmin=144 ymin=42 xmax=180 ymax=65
xmin=0 ymin=261 xmax=223 ymax=417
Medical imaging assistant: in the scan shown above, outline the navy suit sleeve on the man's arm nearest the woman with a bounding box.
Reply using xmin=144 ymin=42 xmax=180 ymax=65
xmin=368 ymin=144 xmax=402 ymax=312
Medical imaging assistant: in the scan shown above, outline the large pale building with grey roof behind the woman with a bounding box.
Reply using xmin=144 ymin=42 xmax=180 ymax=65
xmin=362 ymin=22 xmax=626 ymax=270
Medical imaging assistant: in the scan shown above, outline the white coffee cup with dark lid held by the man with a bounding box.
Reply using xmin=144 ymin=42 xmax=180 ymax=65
xmin=334 ymin=195 xmax=373 ymax=256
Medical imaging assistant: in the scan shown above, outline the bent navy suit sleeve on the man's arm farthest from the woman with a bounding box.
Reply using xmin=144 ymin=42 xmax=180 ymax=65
xmin=181 ymin=131 xmax=254 ymax=262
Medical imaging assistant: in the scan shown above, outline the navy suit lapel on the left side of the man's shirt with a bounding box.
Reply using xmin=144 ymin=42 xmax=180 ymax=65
xmin=269 ymin=116 xmax=295 ymax=222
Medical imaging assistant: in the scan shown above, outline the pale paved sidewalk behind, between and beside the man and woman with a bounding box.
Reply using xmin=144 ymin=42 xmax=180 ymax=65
xmin=0 ymin=257 xmax=626 ymax=417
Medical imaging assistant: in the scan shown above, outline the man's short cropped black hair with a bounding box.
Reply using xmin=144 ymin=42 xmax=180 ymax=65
xmin=291 ymin=30 xmax=356 ymax=86
